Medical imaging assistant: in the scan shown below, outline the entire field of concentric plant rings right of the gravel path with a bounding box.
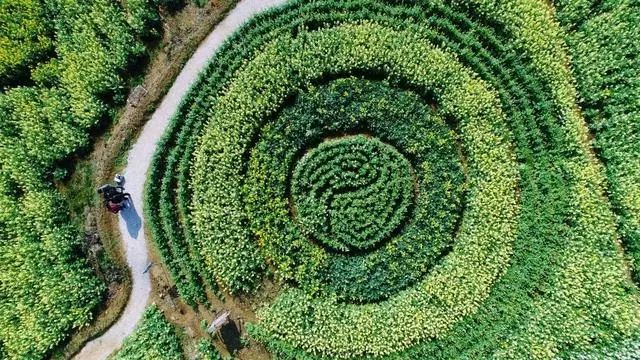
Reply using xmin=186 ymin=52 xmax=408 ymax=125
xmin=145 ymin=0 xmax=640 ymax=359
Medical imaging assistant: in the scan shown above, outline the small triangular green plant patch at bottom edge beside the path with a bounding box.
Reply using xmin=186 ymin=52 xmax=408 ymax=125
xmin=110 ymin=305 xmax=184 ymax=360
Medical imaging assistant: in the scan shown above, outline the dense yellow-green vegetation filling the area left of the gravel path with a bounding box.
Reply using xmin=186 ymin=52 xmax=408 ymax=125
xmin=0 ymin=0 xmax=158 ymax=359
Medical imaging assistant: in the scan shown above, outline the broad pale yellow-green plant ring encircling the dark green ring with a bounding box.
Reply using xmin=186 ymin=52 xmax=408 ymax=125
xmin=193 ymin=23 xmax=518 ymax=357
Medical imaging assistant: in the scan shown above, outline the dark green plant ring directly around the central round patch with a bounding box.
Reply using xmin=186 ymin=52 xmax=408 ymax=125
xmin=245 ymin=78 xmax=464 ymax=302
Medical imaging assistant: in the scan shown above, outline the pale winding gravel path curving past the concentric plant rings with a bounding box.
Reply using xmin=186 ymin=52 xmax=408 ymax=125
xmin=74 ymin=0 xmax=286 ymax=360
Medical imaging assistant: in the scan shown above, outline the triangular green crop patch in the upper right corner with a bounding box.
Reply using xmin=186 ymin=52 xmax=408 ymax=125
xmin=558 ymin=0 xmax=640 ymax=283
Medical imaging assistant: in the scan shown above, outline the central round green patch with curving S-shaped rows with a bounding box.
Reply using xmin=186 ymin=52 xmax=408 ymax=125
xmin=291 ymin=135 xmax=415 ymax=252
